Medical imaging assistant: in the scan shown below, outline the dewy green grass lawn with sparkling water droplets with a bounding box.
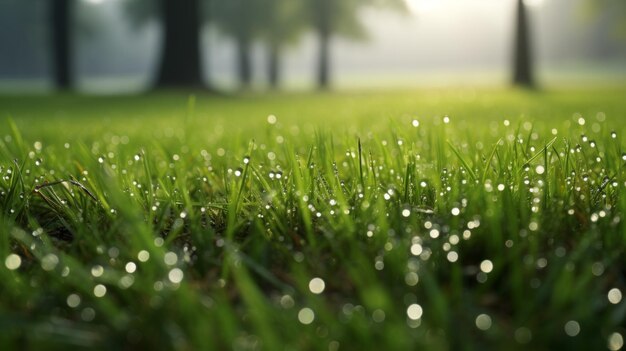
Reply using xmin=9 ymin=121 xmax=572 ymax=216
xmin=0 ymin=88 xmax=626 ymax=350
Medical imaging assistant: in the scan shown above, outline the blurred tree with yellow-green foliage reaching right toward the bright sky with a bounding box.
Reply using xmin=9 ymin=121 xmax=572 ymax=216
xmin=305 ymin=0 xmax=406 ymax=89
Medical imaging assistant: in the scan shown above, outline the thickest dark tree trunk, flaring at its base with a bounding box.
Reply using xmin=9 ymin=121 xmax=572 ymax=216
xmin=155 ymin=0 xmax=203 ymax=88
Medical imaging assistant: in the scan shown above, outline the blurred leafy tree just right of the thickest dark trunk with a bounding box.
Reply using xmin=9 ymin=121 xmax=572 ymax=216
xmin=212 ymin=0 xmax=269 ymax=89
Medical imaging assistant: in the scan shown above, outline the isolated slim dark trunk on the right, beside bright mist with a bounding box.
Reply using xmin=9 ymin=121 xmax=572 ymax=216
xmin=513 ymin=0 xmax=535 ymax=87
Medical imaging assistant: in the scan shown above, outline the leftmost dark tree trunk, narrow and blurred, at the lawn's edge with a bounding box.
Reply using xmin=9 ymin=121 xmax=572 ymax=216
xmin=50 ymin=0 xmax=74 ymax=89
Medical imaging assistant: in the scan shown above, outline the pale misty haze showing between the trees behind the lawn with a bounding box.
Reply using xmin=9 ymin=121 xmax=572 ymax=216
xmin=0 ymin=0 xmax=626 ymax=92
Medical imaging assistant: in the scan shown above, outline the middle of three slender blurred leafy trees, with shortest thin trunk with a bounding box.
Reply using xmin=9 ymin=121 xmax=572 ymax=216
xmin=261 ymin=0 xmax=306 ymax=89
